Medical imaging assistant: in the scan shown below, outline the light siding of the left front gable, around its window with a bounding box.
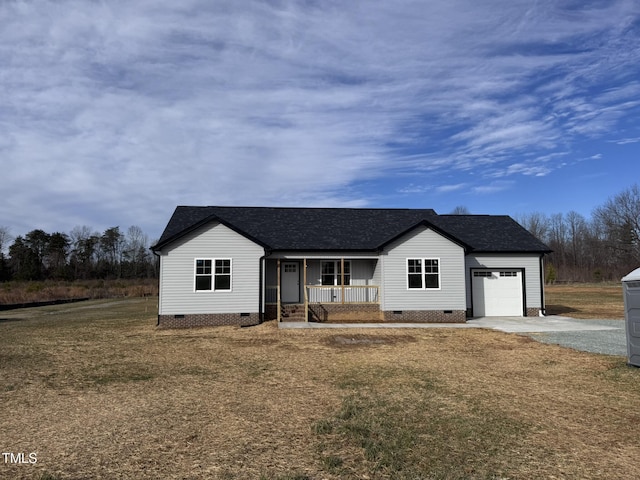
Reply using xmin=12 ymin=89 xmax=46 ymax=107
xmin=159 ymin=223 xmax=264 ymax=315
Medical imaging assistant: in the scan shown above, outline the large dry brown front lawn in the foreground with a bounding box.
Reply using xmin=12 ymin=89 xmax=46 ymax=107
xmin=0 ymin=299 xmax=640 ymax=480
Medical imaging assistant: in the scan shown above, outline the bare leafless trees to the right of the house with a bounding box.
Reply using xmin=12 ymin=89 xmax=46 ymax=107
xmin=516 ymin=184 xmax=640 ymax=283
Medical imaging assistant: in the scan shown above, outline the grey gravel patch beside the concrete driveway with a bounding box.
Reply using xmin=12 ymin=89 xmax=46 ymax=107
xmin=525 ymin=320 xmax=627 ymax=357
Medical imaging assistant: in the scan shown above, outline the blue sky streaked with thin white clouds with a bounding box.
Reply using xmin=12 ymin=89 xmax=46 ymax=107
xmin=0 ymin=0 xmax=640 ymax=239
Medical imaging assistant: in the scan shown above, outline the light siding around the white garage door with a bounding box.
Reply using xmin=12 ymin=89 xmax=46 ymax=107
xmin=465 ymin=254 xmax=542 ymax=308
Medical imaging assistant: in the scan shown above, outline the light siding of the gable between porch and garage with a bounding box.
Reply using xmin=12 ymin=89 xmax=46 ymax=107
xmin=381 ymin=227 xmax=465 ymax=310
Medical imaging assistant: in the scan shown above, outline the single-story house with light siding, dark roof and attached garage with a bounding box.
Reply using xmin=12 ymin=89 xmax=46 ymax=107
xmin=152 ymin=206 xmax=550 ymax=327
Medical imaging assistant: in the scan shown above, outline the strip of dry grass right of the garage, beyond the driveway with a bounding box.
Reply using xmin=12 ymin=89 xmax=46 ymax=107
xmin=545 ymin=282 xmax=624 ymax=319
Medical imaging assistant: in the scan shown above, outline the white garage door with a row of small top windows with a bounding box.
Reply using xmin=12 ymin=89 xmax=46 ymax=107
xmin=473 ymin=270 xmax=523 ymax=317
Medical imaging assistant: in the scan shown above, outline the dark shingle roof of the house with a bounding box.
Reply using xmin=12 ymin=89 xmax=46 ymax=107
xmin=153 ymin=206 xmax=549 ymax=253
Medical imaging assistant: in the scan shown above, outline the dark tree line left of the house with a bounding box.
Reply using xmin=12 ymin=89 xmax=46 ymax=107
xmin=0 ymin=226 xmax=158 ymax=281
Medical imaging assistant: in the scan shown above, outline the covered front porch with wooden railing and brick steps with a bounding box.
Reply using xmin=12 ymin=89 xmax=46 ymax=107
xmin=265 ymin=257 xmax=383 ymax=323
